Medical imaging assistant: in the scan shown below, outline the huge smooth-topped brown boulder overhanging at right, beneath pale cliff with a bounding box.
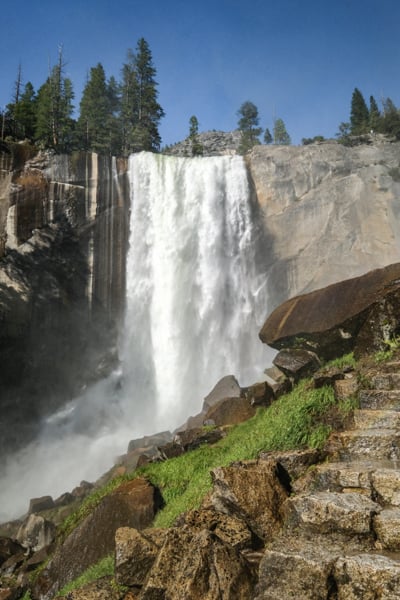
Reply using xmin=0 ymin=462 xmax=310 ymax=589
xmin=260 ymin=263 xmax=400 ymax=360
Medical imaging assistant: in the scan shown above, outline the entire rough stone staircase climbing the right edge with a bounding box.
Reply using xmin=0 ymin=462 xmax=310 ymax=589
xmin=255 ymin=363 xmax=400 ymax=600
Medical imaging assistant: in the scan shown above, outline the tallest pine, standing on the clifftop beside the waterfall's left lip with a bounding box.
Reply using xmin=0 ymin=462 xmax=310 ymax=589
xmin=121 ymin=38 xmax=165 ymax=155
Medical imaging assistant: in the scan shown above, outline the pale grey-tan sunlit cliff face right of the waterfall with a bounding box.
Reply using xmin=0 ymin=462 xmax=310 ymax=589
xmin=247 ymin=136 xmax=400 ymax=311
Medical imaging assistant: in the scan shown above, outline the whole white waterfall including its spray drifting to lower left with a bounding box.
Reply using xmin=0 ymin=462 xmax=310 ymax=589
xmin=0 ymin=153 xmax=271 ymax=522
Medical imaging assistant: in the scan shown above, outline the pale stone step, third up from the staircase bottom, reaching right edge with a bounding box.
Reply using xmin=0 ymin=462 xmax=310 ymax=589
xmin=311 ymin=461 xmax=400 ymax=506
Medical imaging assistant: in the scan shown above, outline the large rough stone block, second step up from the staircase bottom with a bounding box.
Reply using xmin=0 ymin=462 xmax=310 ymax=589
xmin=283 ymin=492 xmax=381 ymax=535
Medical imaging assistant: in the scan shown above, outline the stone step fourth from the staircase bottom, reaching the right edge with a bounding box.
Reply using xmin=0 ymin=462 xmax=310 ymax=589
xmin=331 ymin=429 xmax=400 ymax=461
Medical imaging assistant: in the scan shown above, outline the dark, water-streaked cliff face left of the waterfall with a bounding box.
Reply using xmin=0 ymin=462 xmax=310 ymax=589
xmin=0 ymin=145 xmax=129 ymax=451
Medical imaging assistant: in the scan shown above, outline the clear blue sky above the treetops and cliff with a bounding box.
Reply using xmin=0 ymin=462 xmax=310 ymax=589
xmin=0 ymin=0 xmax=400 ymax=145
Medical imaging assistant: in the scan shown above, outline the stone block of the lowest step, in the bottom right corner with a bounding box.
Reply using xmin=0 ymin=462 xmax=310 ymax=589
xmin=332 ymin=553 xmax=400 ymax=600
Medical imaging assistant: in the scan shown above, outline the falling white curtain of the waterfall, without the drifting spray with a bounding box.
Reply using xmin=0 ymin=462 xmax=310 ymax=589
xmin=122 ymin=153 xmax=267 ymax=428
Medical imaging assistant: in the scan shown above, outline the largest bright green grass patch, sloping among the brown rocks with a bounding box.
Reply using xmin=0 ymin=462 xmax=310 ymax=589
xmin=140 ymin=380 xmax=347 ymax=527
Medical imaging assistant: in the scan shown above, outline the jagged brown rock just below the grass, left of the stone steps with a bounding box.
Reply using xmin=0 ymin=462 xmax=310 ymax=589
xmin=210 ymin=460 xmax=288 ymax=539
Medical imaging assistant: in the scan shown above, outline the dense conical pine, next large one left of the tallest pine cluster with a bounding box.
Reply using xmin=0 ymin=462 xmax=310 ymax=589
xmin=77 ymin=63 xmax=113 ymax=154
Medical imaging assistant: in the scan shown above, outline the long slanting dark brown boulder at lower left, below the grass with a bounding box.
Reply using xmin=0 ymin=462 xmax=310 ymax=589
xmin=35 ymin=478 xmax=158 ymax=598
